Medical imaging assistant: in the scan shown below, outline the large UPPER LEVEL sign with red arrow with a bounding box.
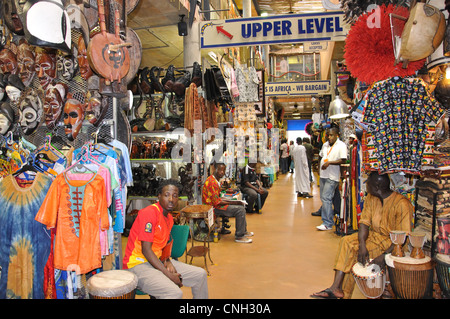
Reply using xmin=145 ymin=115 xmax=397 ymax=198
xmin=200 ymin=11 xmax=350 ymax=49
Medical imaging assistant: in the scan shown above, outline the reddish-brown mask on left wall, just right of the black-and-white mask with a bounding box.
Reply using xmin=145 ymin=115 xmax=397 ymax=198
xmin=44 ymin=83 xmax=67 ymax=130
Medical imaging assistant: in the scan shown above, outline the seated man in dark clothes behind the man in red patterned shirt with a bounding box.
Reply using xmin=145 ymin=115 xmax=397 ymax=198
xmin=241 ymin=163 xmax=269 ymax=213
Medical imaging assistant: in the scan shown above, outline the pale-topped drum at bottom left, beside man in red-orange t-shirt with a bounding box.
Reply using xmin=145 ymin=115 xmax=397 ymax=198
xmin=87 ymin=270 xmax=138 ymax=299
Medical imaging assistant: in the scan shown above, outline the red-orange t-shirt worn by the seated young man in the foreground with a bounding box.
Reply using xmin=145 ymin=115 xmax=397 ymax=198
xmin=123 ymin=202 xmax=173 ymax=269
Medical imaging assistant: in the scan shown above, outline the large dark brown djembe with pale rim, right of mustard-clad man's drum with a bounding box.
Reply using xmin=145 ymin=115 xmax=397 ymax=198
xmin=385 ymin=254 xmax=435 ymax=299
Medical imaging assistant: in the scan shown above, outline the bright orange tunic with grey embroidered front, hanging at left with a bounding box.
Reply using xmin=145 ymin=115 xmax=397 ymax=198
xmin=35 ymin=173 xmax=109 ymax=274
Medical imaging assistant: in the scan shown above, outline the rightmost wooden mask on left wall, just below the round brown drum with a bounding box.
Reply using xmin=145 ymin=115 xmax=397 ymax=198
xmin=86 ymin=75 xmax=108 ymax=126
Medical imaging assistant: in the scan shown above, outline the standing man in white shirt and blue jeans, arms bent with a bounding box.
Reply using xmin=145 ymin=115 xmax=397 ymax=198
xmin=317 ymin=126 xmax=347 ymax=230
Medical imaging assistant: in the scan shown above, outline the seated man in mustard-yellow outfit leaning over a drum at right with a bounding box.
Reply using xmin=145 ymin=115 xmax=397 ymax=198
xmin=311 ymin=172 xmax=414 ymax=299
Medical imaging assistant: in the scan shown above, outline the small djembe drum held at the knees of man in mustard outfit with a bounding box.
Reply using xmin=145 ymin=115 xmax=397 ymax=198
xmin=352 ymin=262 xmax=386 ymax=299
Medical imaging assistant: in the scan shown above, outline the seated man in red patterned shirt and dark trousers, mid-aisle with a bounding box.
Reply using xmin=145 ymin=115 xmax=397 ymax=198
xmin=202 ymin=163 xmax=253 ymax=243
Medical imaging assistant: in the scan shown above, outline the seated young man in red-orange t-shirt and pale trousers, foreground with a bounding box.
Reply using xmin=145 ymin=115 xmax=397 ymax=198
xmin=123 ymin=180 xmax=208 ymax=299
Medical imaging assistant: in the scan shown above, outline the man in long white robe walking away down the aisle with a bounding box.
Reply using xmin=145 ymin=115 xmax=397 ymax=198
xmin=291 ymin=137 xmax=312 ymax=198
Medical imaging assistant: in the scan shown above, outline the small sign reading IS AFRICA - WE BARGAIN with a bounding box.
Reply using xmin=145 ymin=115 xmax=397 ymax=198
xmin=265 ymin=81 xmax=330 ymax=96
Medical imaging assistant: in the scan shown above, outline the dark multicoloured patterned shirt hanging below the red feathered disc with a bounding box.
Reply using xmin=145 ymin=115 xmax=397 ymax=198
xmin=362 ymin=77 xmax=444 ymax=174
